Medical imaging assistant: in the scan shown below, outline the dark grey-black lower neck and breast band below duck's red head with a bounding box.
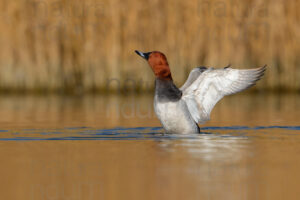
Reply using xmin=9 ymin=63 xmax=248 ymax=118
xmin=155 ymin=78 xmax=182 ymax=101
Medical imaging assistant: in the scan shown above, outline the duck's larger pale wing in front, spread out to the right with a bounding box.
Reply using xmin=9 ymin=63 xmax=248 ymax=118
xmin=181 ymin=66 xmax=266 ymax=123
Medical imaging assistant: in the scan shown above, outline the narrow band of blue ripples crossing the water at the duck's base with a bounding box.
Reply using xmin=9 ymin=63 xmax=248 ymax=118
xmin=0 ymin=126 xmax=300 ymax=141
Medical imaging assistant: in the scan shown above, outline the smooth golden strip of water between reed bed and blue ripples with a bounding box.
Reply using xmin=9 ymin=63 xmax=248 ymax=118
xmin=0 ymin=94 xmax=300 ymax=129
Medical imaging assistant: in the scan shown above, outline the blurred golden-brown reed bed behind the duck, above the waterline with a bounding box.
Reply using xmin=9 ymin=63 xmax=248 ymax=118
xmin=0 ymin=0 xmax=300 ymax=92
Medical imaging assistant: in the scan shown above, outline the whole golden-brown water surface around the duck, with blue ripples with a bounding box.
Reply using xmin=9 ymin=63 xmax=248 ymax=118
xmin=0 ymin=94 xmax=300 ymax=200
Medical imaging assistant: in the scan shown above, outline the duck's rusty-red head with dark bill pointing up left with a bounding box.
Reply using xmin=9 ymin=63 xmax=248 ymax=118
xmin=135 ymin=50 xmax=172 ymax=80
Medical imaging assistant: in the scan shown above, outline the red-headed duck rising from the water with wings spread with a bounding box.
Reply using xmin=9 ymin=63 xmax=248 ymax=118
xmin=135 ymin=50 xmax=266 ymax=134
